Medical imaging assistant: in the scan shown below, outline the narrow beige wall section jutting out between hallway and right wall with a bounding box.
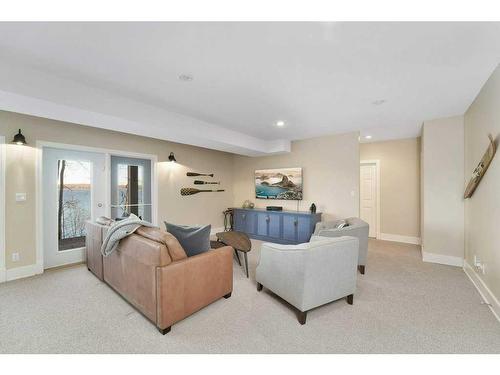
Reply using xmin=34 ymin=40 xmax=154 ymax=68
xmin=422 ymin=116 xmax=464 ymax=266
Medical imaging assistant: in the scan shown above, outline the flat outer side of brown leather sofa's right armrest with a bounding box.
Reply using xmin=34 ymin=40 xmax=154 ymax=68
xmin=156 ymin=246 xmax=233 ymax=328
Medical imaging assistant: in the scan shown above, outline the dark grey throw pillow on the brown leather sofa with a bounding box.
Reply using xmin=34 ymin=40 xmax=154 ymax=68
xmin=165 ymin=221 xmax=212 ymax=257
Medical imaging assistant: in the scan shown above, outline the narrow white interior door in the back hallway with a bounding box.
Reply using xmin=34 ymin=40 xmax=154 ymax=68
xmin=360 ymin=163 xmax=378 ymax=237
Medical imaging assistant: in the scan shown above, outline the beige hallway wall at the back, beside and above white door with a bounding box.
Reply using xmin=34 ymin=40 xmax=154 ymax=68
xmin=359 ymin=138 xmax=420 ymax=238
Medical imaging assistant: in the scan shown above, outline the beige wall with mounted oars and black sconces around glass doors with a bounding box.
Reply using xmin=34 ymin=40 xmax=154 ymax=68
xmin=0 ymin=111 xmax=233 ymax=269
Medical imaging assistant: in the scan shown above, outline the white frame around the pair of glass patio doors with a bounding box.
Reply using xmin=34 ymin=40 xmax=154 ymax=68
xmin=35 ymin=141 xmax=158 ymax=274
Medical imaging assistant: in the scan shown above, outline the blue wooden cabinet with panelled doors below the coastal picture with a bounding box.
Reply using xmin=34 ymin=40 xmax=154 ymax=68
xmin=233 ymin=208 xmax=321 ymax=244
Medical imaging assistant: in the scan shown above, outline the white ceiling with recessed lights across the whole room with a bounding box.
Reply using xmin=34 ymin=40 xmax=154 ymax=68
xmin=0 ymin=22 xmax=500 ymax=155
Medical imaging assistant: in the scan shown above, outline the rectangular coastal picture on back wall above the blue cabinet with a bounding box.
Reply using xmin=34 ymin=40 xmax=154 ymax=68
xmin=255 ymin=168 xmax=302 ymax=200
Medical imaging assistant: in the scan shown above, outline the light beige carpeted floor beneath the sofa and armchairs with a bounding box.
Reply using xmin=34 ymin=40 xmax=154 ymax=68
xmin=0 ymin=240 xmax=500 ymax=353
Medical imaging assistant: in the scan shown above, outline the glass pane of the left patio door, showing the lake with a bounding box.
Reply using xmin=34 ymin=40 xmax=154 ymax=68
xmin=57 ymin=160 xmax=91 ymax=251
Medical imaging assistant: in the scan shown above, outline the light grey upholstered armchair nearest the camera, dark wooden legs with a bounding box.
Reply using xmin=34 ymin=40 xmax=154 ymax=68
xmin=256 ymin=236 xmax=359 ymax=324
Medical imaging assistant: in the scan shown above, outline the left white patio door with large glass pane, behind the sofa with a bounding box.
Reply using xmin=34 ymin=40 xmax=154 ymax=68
xmin=42 ymin=147 xmax=106 ymax=268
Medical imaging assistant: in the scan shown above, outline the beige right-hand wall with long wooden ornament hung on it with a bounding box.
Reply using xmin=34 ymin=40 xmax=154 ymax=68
xmin=464 ymin=67 xmax=500 ymax=302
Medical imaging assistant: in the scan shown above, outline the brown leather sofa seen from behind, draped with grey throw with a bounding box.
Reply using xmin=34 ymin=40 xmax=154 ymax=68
xmin=86 ymin=222 xmax=233 ymax=334
